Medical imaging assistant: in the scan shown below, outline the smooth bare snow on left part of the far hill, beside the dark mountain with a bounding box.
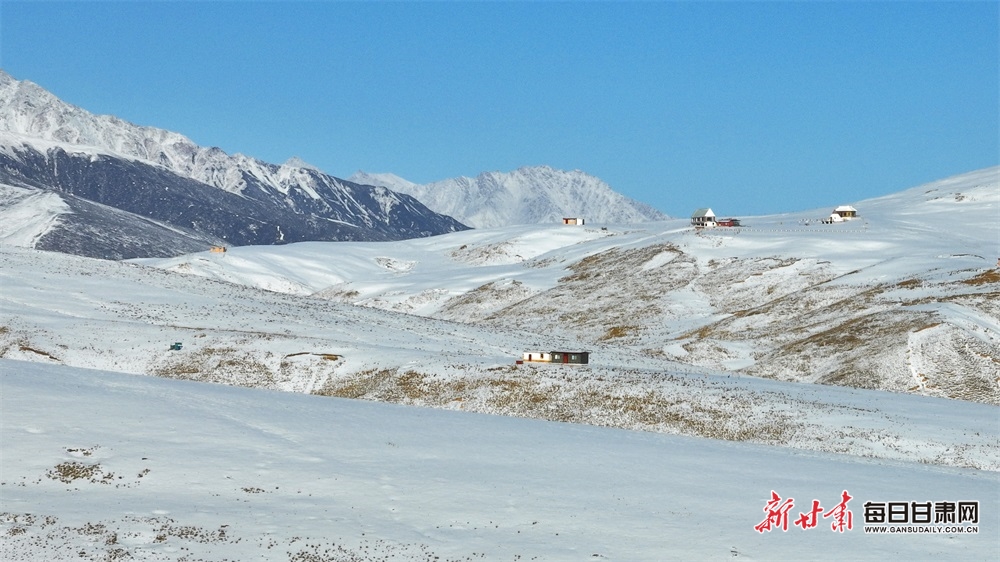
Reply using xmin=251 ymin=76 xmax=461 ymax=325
xmin=135 ymin=220 xmax=613 ymax=315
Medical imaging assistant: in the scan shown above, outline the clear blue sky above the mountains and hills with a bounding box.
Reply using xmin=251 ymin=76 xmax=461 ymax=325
xmin=0 ymin=0 xmax=1000 ymax=216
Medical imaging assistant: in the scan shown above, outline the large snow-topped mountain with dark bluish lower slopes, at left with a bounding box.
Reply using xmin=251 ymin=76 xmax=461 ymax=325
xmin=0 ymin=70 xmax=466 ymax=257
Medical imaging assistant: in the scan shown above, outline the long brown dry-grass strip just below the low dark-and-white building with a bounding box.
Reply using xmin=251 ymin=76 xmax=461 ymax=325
xmin=315 ymin=367 xmax=799 ymax=443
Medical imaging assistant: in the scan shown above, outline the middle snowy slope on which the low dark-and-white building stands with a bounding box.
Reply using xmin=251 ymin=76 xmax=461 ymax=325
xmin=9 ymin=238 xmax=1000 ymax=470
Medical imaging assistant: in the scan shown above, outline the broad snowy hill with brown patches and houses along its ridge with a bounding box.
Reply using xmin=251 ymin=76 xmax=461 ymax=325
xmin=139 ymin=164 xmax=1000 ymax=404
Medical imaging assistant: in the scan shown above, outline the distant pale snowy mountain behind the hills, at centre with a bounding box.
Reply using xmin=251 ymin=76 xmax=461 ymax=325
xmin=351 ymin=166 xmax=667 ymax=228
